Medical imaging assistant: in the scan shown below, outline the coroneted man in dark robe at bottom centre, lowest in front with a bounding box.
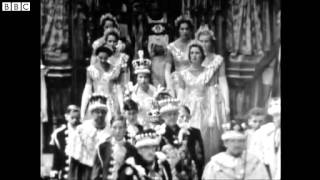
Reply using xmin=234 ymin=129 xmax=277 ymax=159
xmin=118 ymin=129 xmax=172 ymax=180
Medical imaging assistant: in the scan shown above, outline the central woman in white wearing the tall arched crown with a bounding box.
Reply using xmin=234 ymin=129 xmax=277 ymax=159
xmin=131 ymin=50 xmax=156 ymax=126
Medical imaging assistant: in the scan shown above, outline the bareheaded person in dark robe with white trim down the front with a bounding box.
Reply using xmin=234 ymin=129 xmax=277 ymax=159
xmin=91 ymin=116 xmax=137 ymax=180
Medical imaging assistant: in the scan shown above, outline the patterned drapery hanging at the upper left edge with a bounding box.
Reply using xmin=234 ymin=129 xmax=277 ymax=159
xmin=41 ymin=0 xmax=70 ymax=65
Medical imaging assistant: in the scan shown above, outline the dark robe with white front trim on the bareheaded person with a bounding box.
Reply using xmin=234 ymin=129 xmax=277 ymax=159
xmin=91 ymin=138 xmax=137 ymax=180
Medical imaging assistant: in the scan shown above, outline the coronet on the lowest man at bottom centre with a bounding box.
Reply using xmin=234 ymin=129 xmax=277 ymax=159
xmin=134 ymin=129 xmax=161 ymax=148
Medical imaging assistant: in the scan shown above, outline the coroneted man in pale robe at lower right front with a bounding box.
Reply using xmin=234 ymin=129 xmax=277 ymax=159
xmin=202 ymin=122 xmax=269 ymax=180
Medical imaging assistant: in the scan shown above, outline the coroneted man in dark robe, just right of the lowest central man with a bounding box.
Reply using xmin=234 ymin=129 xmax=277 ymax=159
xmin=159 ymin=97 xmax=201 ymax=180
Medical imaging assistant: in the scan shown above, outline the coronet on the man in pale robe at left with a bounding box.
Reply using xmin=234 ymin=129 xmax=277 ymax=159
xmin=88 ymin=93 xmax=108 ymax=112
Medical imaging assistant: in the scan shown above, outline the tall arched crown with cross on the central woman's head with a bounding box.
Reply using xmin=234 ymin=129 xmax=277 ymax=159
xmin=132 ymin=50 xmax=151 ymax=74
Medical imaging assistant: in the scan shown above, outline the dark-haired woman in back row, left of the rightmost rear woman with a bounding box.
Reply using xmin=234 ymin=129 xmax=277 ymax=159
xmin=166 ymin=16 xmax=193 ymax=96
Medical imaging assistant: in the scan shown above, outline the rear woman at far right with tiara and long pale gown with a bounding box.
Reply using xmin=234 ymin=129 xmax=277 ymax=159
xmin=196 ymin=25 xmax=230 ymax=163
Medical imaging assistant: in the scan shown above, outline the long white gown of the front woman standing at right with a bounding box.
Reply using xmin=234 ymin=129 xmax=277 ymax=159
xmin=178 ymin=58 xmax=223 ymax=162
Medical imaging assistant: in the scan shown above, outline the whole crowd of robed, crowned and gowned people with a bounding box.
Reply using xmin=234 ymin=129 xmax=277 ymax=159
xmin=46 ymin=11 xmax=281 ymax=180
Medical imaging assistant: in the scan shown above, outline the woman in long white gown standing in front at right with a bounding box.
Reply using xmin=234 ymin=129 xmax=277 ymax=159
xmin=175 ymin=40 xmax=223 ymax=162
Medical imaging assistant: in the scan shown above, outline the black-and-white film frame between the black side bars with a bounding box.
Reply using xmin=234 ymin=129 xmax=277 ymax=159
xmin=40 ymin=0 xmax=281 ymax=180
